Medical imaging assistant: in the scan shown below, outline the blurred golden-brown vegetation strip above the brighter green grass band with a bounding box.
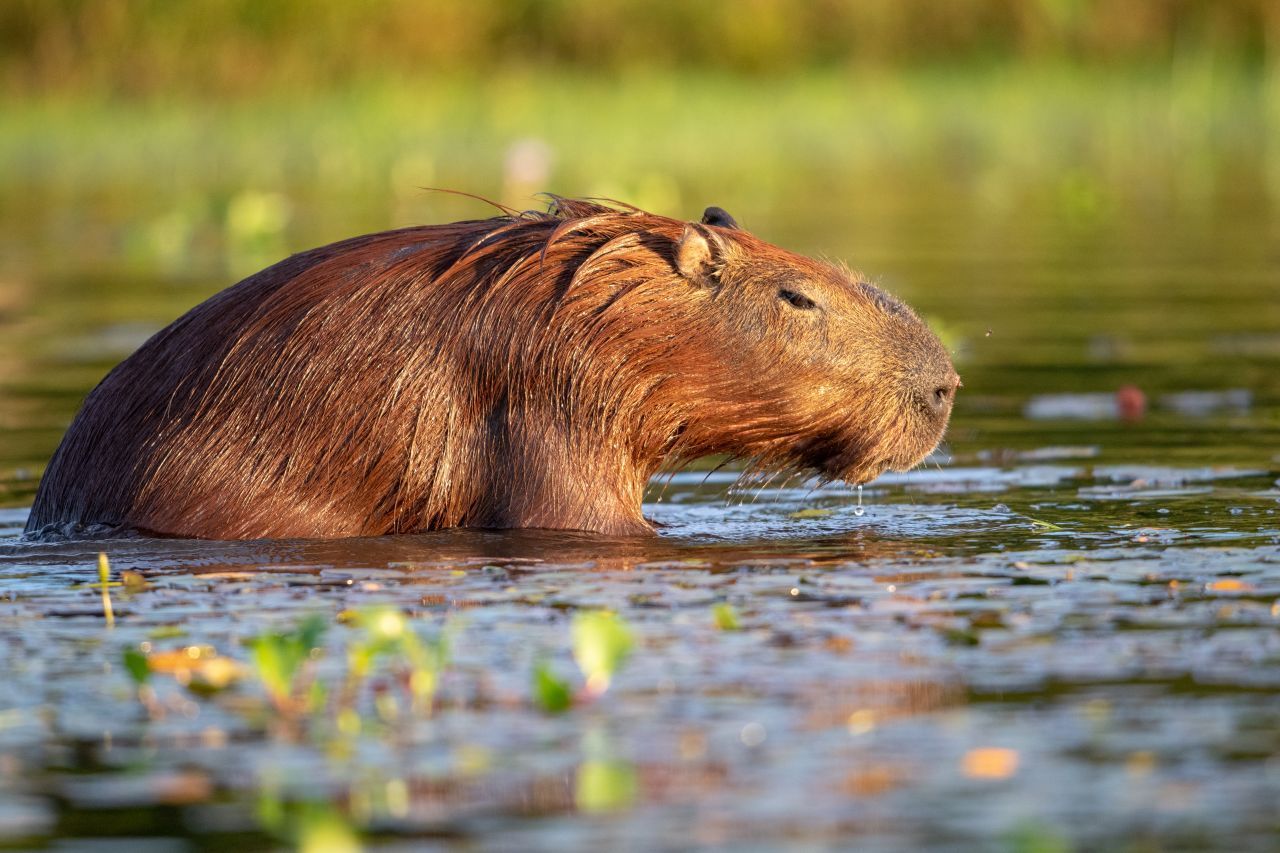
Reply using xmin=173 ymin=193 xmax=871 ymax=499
xmin=0 ymin=0 xmax=1280 ymax=97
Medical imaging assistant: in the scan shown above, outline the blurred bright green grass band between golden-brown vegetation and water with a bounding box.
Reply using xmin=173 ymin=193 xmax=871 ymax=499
xmin=0 ymin=61 xmax=1280 ymax=219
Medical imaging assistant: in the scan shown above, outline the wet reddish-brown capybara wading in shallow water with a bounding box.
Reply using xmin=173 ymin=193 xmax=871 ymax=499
xmin=27 ymin=199 xmax=959 ymax=539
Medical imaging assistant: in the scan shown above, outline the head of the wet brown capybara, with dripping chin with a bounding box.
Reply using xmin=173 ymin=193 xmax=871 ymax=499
xmin=675 ymin=207 xmax=960 ymax=483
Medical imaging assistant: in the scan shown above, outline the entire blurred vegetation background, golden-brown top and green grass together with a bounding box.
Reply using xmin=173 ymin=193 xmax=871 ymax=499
xmin=0 ymin=0 xmax=1280 ymax=268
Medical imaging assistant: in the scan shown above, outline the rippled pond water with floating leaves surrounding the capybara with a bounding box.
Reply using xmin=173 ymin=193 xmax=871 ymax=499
xmin=0 ymin=184 xmax=1280 ymax=850
